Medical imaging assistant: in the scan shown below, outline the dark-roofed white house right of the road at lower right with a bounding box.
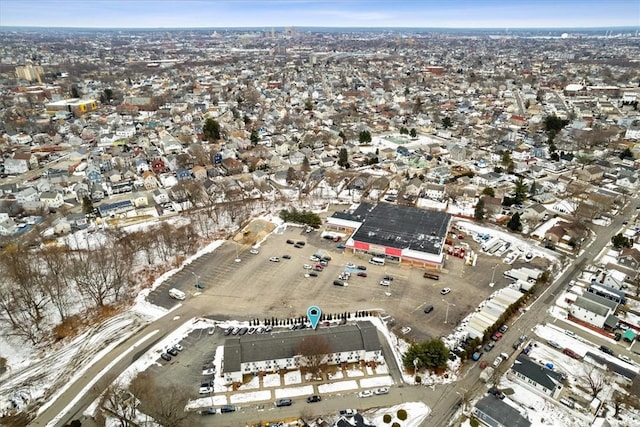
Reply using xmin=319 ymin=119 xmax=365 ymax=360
xmin=509 ymin=354 xmax=562 ymax=399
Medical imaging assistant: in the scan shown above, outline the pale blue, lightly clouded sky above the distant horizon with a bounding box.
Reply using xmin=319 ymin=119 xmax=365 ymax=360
xmin=0 ymin=0 xmax=640 ymax=28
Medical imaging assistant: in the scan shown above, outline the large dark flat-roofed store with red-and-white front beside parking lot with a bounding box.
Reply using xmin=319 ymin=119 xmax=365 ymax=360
xmin=326 ymin=203 xmax=451 ymax=270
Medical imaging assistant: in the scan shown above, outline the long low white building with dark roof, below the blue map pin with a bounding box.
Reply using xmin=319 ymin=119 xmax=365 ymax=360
xmin=223 ymin=321 xmax=383 ymax=384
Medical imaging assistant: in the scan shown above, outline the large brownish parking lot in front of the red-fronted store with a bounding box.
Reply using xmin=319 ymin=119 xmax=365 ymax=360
xmin=149 ymin=226 xmax=528 ymax=340
